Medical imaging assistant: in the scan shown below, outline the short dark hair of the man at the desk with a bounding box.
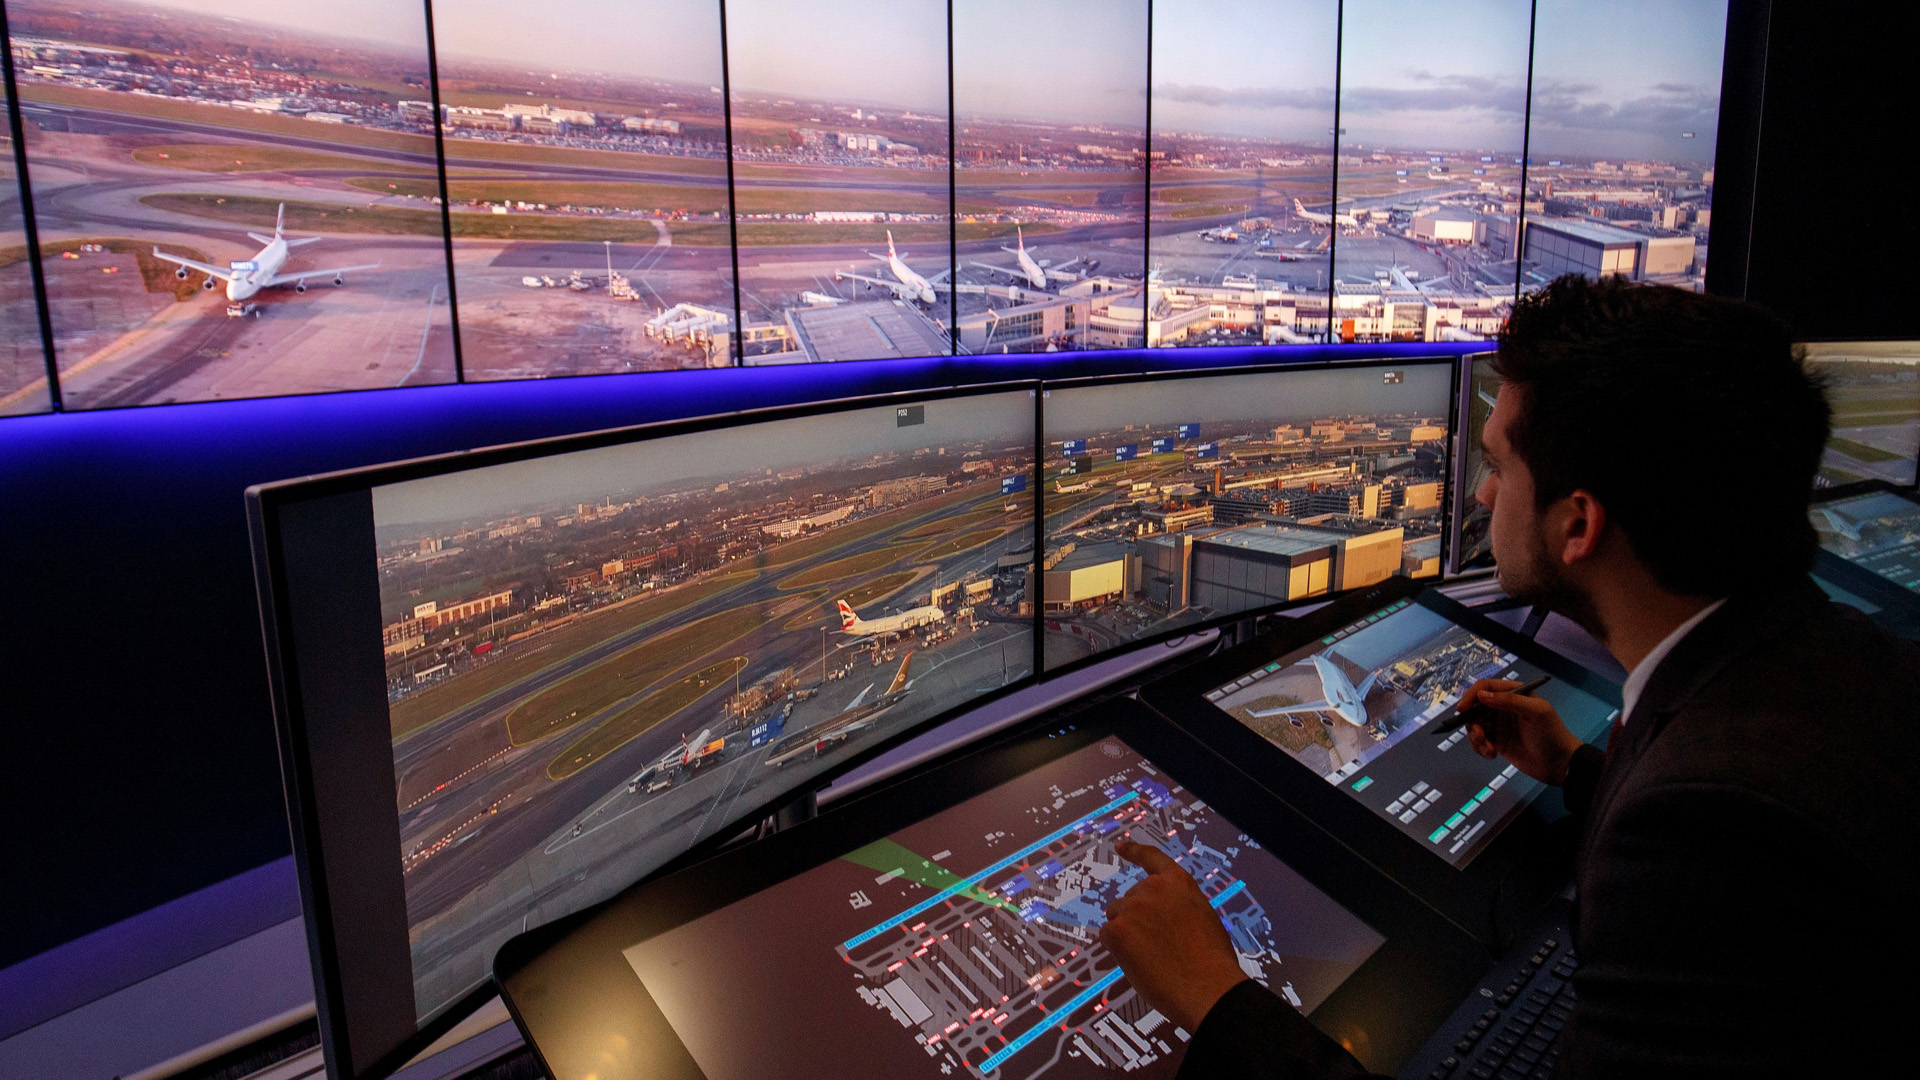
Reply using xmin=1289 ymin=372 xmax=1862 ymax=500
xmin=1494 ymin=275 xmax=1832 ymax=596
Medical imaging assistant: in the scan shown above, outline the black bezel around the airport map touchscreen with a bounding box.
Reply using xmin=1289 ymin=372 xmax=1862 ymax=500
xmin=493 ymin=698 xmax=1488 ymax=1080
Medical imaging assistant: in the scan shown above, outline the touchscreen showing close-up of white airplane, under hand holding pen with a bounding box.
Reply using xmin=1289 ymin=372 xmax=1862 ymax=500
xmin=1208 ymin=600 xmax=1619 ymax=867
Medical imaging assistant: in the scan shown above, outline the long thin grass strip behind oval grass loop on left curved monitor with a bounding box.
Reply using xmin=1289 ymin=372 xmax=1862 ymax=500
xmin=388 ymin=571 xmax=758 ymax=740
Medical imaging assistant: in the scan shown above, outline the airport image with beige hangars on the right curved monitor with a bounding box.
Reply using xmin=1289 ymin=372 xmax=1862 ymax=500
xmin=1039 ymin=363 xmax=1452 ymax=663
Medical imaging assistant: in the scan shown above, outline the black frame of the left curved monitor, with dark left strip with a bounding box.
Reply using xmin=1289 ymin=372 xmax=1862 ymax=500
xmin=246 ymin=379 xmax=1044 ymax=1080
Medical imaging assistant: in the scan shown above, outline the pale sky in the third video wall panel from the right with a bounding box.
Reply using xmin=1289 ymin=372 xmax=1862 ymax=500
xmin=1154 ymin=0 xmax=1340 ymax=144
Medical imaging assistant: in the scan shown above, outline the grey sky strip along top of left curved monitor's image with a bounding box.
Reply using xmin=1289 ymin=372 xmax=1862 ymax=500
xmin=372 ymin=390 xmax=1033 ymax=530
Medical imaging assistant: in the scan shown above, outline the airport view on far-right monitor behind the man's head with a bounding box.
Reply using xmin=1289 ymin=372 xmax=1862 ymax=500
xmin=1805 ymin=342 xmax=1920 ymax=484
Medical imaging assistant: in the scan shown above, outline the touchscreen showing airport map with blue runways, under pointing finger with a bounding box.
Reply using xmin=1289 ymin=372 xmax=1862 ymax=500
xmin=626 ymin=738 xmax=1384 ymax=1080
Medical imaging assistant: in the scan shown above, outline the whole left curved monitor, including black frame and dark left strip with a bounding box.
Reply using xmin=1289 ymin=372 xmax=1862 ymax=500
xmin=252 ymin=384 xmax=1037 ymax=1076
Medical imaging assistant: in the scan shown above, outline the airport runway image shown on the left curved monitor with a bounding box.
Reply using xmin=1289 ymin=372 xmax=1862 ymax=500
xmin=372 ymin=390 xmax=1033 ymax=1017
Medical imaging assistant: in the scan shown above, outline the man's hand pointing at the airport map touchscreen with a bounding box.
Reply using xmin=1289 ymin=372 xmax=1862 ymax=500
xmin=1100 ymin=840 xmax=1246 ymax=1034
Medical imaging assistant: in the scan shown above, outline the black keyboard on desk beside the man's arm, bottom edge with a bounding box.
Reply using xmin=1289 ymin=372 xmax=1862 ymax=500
xmin=1400 ymin=913 xmax=1578 ymax=1080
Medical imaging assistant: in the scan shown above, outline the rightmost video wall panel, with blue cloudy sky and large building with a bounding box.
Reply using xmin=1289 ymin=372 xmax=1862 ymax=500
xmin=1521 ymin=0 xmax=1726 ymax=290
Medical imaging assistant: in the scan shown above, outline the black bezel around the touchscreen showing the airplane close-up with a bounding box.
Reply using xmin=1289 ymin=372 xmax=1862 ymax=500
xmin=1140 ymin=578 xmax=1620 ymax=947
